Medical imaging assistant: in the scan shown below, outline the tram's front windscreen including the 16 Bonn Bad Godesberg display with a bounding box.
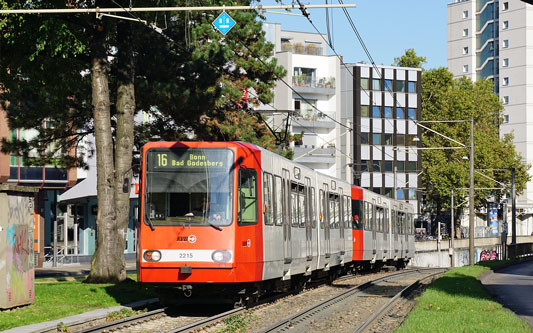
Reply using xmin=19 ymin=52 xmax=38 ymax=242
xmin=144 ymin=148 xmax=234 ymax=226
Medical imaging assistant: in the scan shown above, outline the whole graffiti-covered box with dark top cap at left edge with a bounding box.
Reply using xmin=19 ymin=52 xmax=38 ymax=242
xmin=0 ymin=185 xmax=38 ymax=309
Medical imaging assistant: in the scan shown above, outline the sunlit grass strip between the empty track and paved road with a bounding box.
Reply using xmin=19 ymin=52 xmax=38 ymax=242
xmin=395 ymin=261 xmax=530 ymax=333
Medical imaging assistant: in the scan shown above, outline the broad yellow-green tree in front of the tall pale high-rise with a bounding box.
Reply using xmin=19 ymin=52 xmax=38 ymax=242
xmin=421 ymin=67 xmax=530 ymax=228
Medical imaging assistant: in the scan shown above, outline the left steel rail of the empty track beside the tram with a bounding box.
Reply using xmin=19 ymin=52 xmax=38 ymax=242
xmin=254 ymin=269 xmax=440 ymax=333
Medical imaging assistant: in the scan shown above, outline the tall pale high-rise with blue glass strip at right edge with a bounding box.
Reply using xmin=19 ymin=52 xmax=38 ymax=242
xmin=448 ymin=0 xmax=533 ymax=235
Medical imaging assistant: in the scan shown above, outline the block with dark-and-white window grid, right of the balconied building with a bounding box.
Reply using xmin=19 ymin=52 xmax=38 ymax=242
xmin=341 ymin=62 xmax=422 ymax=213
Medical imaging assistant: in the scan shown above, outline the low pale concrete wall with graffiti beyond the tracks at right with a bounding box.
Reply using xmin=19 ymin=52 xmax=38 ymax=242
xmin=409 ymin=236 xmax=533 ymax=267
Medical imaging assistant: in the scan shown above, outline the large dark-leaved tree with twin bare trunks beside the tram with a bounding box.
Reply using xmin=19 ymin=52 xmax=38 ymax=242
xmin=0 ymin=0 xmax=283 ymax=282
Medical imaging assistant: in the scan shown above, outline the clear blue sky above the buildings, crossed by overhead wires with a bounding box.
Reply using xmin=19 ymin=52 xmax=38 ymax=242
xmin=261 ymin=0 xmax=452 ymax=69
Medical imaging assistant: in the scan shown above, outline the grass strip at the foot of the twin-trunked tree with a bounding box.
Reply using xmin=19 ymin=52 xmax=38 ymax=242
xmin=0 ymin=274 xmax=157 ymax=331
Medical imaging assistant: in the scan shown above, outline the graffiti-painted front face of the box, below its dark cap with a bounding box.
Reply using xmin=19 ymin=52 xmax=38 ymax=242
xmin=6 ymin=196 xmax=35 ymax=305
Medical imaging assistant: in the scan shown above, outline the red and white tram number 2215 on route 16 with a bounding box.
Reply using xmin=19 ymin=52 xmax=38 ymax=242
xmin=137 ymin=142 xmax=414 ymax=302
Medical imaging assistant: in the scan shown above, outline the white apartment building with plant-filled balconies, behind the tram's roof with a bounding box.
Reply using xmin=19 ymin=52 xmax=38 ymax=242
xmin=258 ymin=23 xmax=343 ymax=177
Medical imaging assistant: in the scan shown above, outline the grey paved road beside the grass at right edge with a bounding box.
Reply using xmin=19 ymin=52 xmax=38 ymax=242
xmin=481 ymin=261 xmax=533 ymax=328
